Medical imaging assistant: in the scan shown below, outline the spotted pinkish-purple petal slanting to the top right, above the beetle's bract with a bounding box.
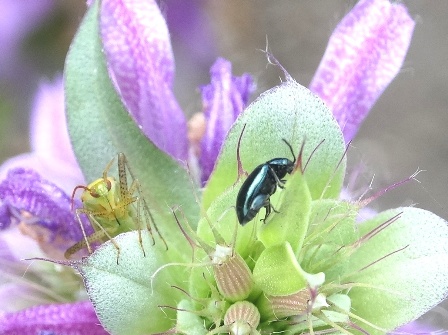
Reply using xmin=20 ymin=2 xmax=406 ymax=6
xmin=309 ymin=0 xmax=415 ymax=142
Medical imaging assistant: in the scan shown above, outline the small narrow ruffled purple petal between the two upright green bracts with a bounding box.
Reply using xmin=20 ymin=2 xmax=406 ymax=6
xmin=199 ymin=58 xmax=254 ymax=183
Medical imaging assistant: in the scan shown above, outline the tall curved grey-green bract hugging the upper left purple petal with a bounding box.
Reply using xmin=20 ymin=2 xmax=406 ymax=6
xmin=64 ymin=1 xmax=199 ymax=232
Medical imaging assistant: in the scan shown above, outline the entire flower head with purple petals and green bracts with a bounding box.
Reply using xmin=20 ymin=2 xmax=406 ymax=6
xmin=0 ymin=0 xmax=448 ymax=335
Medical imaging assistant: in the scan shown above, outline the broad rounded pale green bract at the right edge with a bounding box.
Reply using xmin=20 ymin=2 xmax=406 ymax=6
xmin=342 ymin=207 xmax=448 ymax=334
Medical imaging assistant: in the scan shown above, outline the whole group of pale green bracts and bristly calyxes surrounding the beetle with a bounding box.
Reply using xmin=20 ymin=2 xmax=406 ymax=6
xmin=65 ymin=5 xmax=448 ymax=335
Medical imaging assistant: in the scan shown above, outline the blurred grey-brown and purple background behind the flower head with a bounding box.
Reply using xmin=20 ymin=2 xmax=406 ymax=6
xmin=0 ymin=0 xmax=448 ymax=330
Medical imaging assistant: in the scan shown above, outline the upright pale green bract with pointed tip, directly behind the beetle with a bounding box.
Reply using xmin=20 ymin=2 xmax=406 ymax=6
xmin=203 ymin=78 xmax=346 ymax=209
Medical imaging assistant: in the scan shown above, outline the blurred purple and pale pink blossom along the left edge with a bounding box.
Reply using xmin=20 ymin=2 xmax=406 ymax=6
xmin=0 ymin=78 xmax=92 ymax=334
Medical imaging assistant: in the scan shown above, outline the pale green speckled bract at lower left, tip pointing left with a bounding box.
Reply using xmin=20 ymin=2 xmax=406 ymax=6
xmin=74 ymin=231 xmax=186 ymax=335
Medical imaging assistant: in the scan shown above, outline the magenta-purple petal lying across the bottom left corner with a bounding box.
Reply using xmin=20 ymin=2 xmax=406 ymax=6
xmin=0 ymin=301 xmax=108 ymax=335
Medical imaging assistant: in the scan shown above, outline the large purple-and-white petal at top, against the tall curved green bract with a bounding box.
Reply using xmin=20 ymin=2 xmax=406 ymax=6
xmin=100 ymin=0 xmax=188 ymax=160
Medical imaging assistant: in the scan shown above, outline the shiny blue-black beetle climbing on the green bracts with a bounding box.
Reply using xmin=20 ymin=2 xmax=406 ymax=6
xmin=236 ymin=138 xmax=296 ymax=226
